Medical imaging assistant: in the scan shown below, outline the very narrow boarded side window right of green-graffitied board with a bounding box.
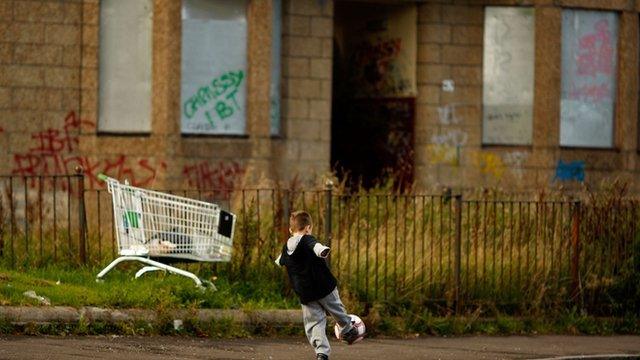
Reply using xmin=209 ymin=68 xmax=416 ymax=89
xmin=269 ymin=0 xmax=282 ymax=135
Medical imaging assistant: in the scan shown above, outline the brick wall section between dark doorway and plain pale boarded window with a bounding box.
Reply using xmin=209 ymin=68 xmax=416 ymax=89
xmin=416 ymin=3 xmax=484 ymax=187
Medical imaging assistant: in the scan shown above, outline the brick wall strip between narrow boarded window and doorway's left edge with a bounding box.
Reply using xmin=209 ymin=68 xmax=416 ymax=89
xmin=277 ymin=0 xmax=333 ymax=186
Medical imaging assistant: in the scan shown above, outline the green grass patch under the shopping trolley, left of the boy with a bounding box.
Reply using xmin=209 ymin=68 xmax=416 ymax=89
xmin=0 ymin=265 xmax=299 ymax=309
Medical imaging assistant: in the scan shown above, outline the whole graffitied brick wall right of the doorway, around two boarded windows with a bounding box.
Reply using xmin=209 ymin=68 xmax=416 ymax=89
xmin=416 ymin=0 xmax=640 ymax=191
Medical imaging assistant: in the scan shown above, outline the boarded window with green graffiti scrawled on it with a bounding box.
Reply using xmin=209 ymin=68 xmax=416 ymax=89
xmin=180 ymin=0 xmax=247 ymax=135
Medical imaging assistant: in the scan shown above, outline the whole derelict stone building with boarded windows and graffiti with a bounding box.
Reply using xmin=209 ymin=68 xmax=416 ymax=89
xmin=0 ymin=0 xmax=640 ymax=191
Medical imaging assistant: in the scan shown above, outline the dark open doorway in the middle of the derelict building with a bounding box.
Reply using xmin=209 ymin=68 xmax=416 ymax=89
xmin=331 ymin=2 xmax=416 ymax=188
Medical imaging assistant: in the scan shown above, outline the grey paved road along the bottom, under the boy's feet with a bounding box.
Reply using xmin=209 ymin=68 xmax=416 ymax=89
xmin=0 ymin=336 xmax=640 ymax=360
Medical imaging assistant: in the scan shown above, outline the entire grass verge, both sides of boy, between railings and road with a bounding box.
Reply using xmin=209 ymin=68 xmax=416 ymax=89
xmin=0 ymin=266 xmax=640 ymax=338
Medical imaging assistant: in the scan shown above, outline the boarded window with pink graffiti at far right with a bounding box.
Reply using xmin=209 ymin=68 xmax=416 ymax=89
xmin=560 ymin=10 xmax=618 ymax=148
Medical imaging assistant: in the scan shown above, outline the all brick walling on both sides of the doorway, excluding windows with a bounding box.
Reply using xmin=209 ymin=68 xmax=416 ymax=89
xmin=0 ymin=0 xmax=640 ymax=194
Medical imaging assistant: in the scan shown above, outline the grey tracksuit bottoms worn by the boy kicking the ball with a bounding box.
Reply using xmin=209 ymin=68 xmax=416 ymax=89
xmin=302 ymin=288 xmax=352 ymax=356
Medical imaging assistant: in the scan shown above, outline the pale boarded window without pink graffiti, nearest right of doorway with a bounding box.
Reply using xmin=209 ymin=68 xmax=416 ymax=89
xmin=482 ymin=6 xmax=535 ymax=145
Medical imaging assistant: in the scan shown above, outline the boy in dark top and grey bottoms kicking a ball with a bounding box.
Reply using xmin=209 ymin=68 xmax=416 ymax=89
xmin=276 ymin=211 xmax=362 ymax=360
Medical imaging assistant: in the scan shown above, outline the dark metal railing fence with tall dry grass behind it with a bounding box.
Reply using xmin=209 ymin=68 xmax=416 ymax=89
xmin=0 ymin=175 xmax=640 ymax=313
